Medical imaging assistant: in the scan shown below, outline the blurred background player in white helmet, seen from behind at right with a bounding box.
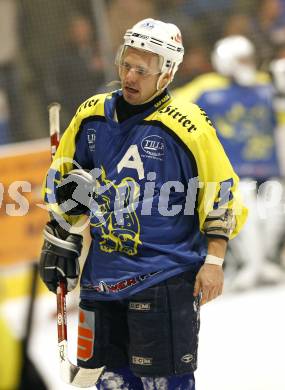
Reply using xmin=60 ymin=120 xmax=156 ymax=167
xmin=175 ymin=35 xmax=284 ymax=289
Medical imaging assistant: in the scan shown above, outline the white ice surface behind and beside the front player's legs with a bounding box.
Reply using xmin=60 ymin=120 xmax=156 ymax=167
xmin=2 ymin=285 xmax=285 ymax=390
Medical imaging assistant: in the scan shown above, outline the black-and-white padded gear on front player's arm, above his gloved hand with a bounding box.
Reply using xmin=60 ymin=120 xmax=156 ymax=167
xmin=55 ymin=169 xmax=95 ymax=215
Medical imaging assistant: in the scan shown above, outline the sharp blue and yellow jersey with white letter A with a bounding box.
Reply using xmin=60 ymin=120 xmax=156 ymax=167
xmin=42 ymin=91 xmax=247 ymax=300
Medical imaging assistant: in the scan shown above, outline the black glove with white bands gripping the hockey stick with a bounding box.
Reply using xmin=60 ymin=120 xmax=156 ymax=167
xmin=40 ymin=221 xmax=82 ymax=292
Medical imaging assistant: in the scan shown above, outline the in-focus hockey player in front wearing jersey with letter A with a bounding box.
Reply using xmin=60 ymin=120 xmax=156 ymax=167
xmin=40 ymin=19 xmax=247 ymax=390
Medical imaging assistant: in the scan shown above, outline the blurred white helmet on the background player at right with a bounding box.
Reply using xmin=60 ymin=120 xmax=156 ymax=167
xmin=212 ymin=35 xmax=256 ymax=86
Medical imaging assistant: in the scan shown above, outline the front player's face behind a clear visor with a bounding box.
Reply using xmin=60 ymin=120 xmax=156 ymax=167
xmin=119 ymin=48 xmax=160 ymax=105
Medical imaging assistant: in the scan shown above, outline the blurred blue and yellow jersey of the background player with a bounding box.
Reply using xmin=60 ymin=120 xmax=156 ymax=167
xmin=174 ymin=73 xmax=280 ymax=180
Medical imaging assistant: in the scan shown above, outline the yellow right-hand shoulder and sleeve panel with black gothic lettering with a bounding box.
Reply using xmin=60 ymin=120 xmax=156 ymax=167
xmin=146 ymin=99 xmax=247 ymax=238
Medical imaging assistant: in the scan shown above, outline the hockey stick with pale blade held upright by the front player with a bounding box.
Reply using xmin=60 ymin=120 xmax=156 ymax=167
xmin=48 ymin=103 xmax=105 ymax=387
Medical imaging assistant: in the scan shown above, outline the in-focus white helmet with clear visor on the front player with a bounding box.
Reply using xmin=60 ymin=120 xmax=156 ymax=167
xmin=118 ymin=18 xmax=184 ymax=81
